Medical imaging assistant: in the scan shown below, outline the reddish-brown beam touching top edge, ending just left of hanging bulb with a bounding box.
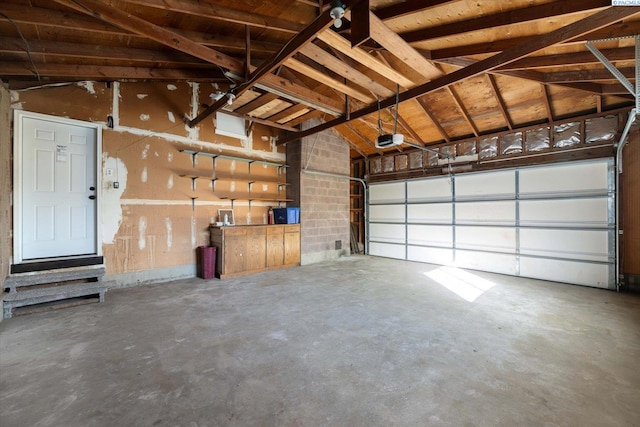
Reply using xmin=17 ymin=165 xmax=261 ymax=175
xmin=124 ymin=0 xmax=304 ymax=34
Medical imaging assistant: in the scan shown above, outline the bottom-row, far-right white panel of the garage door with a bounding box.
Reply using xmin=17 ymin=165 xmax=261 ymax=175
xmin=520 ymin=257 xmax=615 ymax=289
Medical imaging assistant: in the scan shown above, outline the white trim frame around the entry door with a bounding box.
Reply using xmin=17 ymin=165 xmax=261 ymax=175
xmin=12 ymin=110 xmax=102 ymax=264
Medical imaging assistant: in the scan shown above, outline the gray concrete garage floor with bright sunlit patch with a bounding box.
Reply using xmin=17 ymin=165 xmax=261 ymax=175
xmin=0 ymin=256 xmax=640 ymax=427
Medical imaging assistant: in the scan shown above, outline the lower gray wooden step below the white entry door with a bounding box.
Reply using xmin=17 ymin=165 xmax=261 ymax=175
xmin=3 ymin=282 xmax=110 ymax=319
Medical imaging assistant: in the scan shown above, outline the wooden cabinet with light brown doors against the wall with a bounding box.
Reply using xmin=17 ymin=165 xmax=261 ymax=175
xmin=209 ymin=224 xmax=300 ymax=278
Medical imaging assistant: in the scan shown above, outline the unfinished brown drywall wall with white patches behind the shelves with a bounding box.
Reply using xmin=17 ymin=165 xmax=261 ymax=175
xmin=6 ymin=82 xmax=286 ymax=286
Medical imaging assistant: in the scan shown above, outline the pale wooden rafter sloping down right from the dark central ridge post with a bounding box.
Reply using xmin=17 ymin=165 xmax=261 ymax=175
xmin=369 ymin=13 xmax=443 ymax=80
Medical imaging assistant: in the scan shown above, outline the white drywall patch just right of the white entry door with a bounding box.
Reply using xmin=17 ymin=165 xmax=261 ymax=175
xmin=101 ymin=153 xmax=127 ymax=245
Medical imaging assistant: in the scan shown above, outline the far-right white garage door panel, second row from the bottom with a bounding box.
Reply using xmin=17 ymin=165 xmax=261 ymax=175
xmin=520 ymin=229 xmax=609 ymax=262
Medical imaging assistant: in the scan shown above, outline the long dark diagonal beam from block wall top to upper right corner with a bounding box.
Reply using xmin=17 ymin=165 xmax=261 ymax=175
xmin=278 ymin=6 xmax=640 ymax=144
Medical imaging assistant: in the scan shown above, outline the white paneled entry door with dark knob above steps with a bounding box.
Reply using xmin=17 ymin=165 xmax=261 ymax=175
xmin=15 ymin=112 xmax=98 ymax=262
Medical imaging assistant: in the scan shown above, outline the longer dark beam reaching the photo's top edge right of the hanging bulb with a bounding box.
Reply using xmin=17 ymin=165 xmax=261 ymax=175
xmin=400 ymin=0 xmax=611 ymax=43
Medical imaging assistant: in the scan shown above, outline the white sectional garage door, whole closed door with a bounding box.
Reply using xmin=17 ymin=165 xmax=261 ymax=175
xmin=369 ymin=159 xmax=615 ymax=289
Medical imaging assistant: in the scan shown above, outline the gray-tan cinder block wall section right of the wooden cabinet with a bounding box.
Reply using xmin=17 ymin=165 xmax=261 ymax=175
xmin=287 ymin=122 xmax=350 ymax=265
